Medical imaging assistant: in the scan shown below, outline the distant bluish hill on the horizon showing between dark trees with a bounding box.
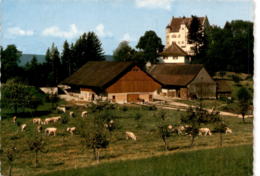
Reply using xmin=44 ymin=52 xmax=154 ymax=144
xmin=19 ymin=54 xmax=113 ymax=66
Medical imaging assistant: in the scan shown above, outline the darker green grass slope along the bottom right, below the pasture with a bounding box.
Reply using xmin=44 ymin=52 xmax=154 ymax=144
xmin=38 ymin=145 xmax=253 ymax=176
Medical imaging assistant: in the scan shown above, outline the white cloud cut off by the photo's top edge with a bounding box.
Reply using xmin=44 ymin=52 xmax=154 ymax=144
xmin=135 ymin=0 xmax=174 ymax=10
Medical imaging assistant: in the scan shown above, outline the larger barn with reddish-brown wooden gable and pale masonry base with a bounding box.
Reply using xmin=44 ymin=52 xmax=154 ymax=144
xmin=62 ymin=61 xmax=161 ymax=103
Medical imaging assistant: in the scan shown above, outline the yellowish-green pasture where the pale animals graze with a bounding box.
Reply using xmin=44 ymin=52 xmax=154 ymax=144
xmin=1 ymin=102 xmax=253 ymax=176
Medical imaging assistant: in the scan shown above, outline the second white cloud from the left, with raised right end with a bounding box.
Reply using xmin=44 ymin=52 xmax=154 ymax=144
xmin=42 ymin=24 xmax=79 ymax=38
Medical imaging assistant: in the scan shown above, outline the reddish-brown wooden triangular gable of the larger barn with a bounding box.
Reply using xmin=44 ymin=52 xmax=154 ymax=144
xmin=106 ymin=66 xmax=161 ymax=93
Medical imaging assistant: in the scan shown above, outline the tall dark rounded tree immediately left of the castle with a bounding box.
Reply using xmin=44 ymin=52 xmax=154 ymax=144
xmin=136 ymin=31 xmax=163 ymax=64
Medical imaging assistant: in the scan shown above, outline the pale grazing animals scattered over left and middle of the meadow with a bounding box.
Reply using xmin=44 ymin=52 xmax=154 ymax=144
xmin=13 ymin=106 xmax=136 ymax=141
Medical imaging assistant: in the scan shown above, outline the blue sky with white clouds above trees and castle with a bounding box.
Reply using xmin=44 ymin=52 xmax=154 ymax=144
xmin=0 ymin=0 xmax=254 ymax=54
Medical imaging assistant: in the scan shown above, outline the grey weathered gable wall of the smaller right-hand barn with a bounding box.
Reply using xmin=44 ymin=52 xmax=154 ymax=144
xmin=187 ymin=68 xmax=216 ymax=99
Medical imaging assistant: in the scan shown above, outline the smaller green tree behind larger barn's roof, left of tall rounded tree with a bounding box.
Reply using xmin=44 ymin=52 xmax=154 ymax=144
xmin=113 ymin=41 xmax=134 ymax=61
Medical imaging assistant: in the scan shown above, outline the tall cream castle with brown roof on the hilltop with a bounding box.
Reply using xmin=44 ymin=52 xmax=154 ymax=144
xmin=165 ymin=17 xmax=209 ymax=55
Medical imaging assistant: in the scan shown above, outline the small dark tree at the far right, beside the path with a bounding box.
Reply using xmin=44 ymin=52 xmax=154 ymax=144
xmin=237 ymin=87 xmax=252 ymax=122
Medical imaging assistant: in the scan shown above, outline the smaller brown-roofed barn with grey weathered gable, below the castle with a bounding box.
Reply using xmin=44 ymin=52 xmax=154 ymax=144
xmin=148 ymin=63 xmax=216 ymax=99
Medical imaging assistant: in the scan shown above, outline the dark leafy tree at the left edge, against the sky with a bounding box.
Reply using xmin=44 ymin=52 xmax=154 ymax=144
xmin=0 ymin=45 xmax=22 ymax=83
